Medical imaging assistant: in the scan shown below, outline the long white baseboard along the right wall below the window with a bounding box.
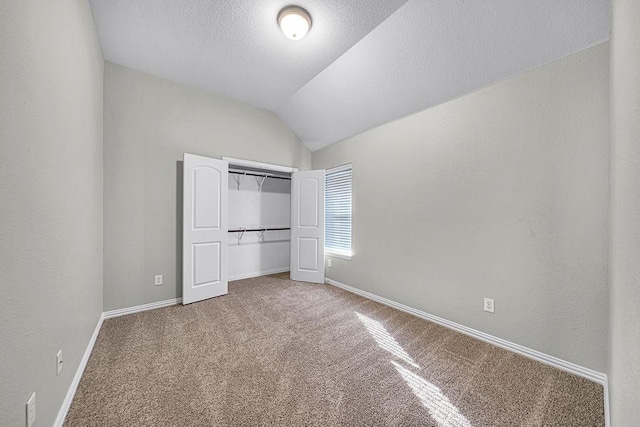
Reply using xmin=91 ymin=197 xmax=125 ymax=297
xmin=325 ymin=278 xmax=608 ymax=388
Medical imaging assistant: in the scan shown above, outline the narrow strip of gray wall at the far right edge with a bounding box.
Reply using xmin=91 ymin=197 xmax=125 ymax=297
xmin=609 ymin=0 xmax=640 ymax=426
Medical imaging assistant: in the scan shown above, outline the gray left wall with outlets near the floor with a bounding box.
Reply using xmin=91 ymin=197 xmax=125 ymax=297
xmin=0 ymin=0 xmax=104 ymax=426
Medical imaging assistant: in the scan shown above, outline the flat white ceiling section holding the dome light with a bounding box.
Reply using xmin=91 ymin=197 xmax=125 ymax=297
xmin=90 ymin=0 xmax=406 ymax=110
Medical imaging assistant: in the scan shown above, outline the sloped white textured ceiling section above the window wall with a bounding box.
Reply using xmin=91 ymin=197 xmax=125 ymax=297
xmin=277 ymin=0 xmax=610 ymax=151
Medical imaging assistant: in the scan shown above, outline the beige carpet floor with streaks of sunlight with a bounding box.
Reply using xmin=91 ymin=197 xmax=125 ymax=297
xmin=65 ymin=274 xmax=604 ymax=427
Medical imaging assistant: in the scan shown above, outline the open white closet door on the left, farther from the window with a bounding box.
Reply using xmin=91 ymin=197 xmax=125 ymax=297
xmin=182 ymin=153 xmax=229 ymax=304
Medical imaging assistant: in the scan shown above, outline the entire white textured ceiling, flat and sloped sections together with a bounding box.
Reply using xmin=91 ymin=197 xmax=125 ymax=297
xmin=91 ymin=0 xmax=610 ymax=151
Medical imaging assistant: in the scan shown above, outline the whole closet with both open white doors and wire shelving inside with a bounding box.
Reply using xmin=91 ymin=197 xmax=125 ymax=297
xmin=182 ymin=153 xmax=325 ymax=304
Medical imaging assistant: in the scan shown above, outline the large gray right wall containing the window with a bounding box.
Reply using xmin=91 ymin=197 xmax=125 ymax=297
xmin=313 ymin=44 xmax=609 ymax=372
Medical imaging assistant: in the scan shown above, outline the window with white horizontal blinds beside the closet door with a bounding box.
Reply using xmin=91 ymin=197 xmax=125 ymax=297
xmin=324 ymin=164 xmax=352 ymax=259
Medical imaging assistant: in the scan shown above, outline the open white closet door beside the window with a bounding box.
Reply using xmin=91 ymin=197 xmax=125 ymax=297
xmin=290 ymin=170 xmax=324 ymax=283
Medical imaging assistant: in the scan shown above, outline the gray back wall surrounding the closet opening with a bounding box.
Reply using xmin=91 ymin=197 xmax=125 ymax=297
xmin=104 ymin=62 xmax=311 ymax=310
